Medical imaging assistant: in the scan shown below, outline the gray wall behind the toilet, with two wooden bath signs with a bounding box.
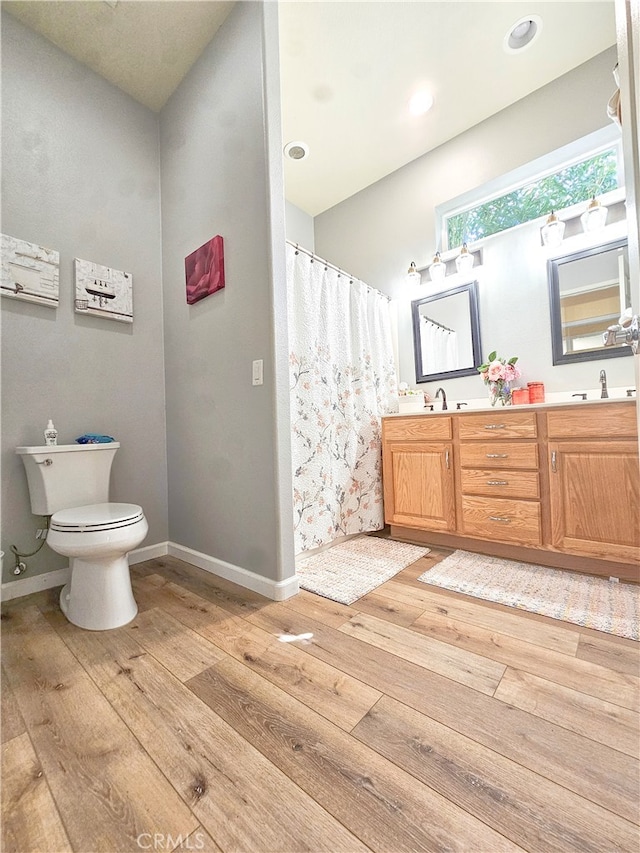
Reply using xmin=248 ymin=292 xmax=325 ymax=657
xmin=1 ymin=14 xmax=168 ymax=581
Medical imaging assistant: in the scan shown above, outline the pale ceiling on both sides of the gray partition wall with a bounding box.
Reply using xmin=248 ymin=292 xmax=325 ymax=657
xmin=2 ymin=0 xmax=616 ymax=216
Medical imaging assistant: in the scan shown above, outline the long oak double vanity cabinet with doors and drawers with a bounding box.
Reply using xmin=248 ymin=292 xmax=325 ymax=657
xmin=382 ymin=400 xmax=640 ymax=581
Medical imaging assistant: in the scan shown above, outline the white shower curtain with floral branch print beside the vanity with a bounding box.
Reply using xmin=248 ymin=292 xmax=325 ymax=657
xmin=287 ymin=244 xmax=397 ymax=554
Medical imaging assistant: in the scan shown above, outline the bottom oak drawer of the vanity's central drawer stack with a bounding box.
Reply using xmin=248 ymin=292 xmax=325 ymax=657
xmin=462 ymin=495 xmax=542 ymax=545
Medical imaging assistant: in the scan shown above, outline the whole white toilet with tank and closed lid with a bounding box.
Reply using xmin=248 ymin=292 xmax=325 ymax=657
xmin=16 ymin=441 xmax=149 ymax=631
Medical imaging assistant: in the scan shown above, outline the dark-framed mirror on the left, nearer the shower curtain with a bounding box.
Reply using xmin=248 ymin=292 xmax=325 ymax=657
xmin=411 ymin=281 xmax=482 ymax=382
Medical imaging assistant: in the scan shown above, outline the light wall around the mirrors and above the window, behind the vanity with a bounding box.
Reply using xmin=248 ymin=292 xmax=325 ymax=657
xmin=314 ymin=48 xmax=633 ymax=398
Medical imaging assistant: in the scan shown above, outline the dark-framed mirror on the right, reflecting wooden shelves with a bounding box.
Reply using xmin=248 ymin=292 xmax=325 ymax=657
xmin=547 ymin=238 xmax=631 ymax=364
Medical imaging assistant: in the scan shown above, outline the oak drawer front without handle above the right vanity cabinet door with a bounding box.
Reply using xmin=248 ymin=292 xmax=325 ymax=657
xmin=547 ymin=400 xmax=637 ymax=438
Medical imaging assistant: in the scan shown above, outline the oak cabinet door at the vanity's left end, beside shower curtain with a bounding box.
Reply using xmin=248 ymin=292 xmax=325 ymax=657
xmin=384 ymin=441 xmax=456 ymax=530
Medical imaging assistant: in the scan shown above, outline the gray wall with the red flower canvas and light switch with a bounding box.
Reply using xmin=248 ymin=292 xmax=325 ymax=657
xmin=160 ymin=3 xmax=293 ymax=579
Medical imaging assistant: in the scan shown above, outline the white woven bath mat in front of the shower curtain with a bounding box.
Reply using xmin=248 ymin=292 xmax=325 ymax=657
xmin=297 ymin=535 xmax=429 ymax=604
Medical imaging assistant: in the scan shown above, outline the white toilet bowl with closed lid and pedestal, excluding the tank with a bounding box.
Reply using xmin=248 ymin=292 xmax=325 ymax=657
xmin=47 ymin=503 xmax=149 ymax=631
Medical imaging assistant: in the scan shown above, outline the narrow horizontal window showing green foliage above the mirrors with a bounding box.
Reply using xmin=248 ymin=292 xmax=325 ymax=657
xmin=445 ymin=146 xmax=619 ymax=248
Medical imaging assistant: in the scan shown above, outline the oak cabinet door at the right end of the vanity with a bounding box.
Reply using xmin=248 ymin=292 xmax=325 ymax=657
xmin=549 ymin=441 xmax=640 ymax=563
